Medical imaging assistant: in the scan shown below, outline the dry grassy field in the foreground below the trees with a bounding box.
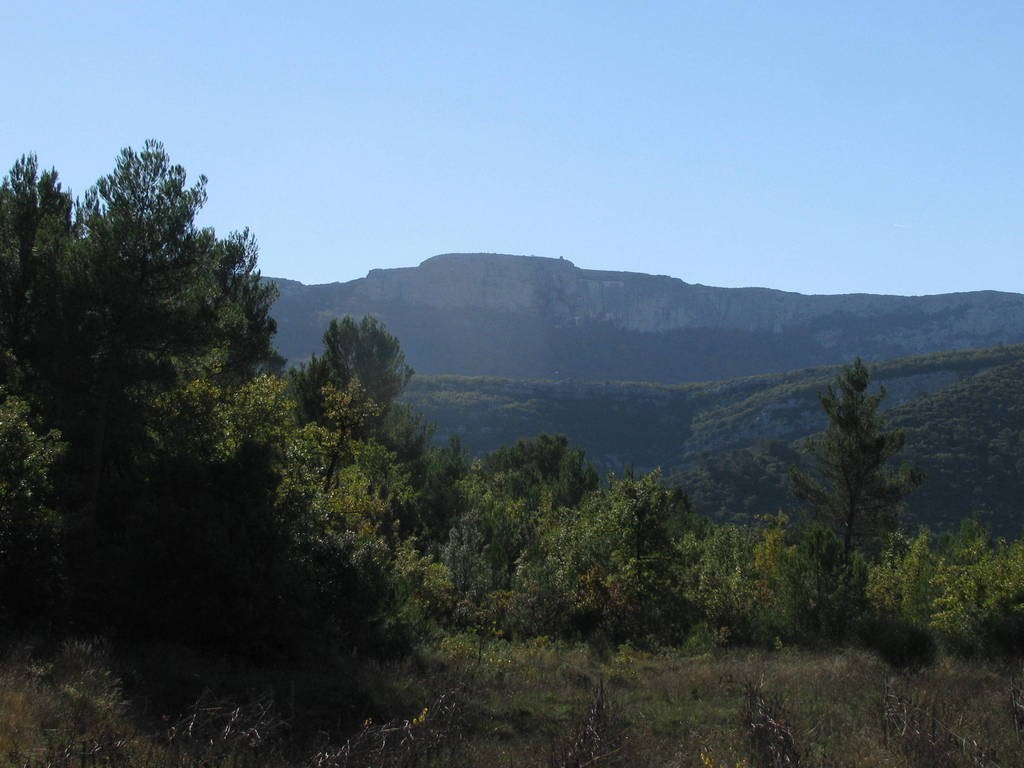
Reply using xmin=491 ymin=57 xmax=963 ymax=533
xmin=0 ymin=636 xmax=1024 ymax=768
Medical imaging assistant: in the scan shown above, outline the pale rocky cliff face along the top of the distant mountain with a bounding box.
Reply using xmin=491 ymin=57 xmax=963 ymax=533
xmin=353 ymin=254 xmax=1024 ymax=338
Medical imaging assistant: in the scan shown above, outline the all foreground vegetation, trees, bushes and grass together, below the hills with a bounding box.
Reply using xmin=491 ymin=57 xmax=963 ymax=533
xmin=0 ymin=142 xmax=1024 ymax=768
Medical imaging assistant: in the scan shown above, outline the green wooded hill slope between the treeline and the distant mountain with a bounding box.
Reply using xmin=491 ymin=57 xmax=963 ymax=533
xmin=406 ymin=346 xmax=1024 ymax=536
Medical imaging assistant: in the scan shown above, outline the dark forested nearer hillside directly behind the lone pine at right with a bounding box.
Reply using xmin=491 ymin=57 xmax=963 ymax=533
xmin=674 ymin=349 xmax=1024 ymax=537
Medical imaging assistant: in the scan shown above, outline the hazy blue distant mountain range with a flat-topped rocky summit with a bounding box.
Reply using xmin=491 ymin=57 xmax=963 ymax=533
xmin=272 ymin=254 xmax=1024 ymax=383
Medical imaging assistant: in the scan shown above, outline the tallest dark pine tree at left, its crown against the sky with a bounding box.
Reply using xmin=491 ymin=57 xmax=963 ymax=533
xmin=66 ymin=141 xmax=273 ymax=528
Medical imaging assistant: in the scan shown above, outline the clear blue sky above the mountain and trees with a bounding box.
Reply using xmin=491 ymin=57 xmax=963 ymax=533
xmin=0 ymin=0 xmax=1024 ymax=294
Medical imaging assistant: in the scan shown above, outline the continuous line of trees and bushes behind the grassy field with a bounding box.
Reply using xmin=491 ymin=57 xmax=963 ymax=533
xmin=0 ymin=142 xmax=1024 ymax=664
